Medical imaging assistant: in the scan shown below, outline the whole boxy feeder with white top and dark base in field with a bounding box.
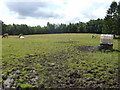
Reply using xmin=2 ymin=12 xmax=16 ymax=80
xmin=100 ymin=34 xmax=113 ymax=49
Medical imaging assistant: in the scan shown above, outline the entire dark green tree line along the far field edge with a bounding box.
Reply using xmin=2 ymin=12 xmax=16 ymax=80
xmin=2 ymin=1 xmax=120 ymax=35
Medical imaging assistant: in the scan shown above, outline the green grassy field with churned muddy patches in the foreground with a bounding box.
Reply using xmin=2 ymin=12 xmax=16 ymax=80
xmin=2 ymin=34 xmax=119 ymax=88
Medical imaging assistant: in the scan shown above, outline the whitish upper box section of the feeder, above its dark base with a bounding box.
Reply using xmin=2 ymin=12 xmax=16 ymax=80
xmin=100 ymin=34 xmax=113 ymax=45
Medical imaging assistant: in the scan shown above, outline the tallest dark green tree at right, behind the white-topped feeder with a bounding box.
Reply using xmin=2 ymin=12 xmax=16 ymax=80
xmin=103 ymin=1 xmax=120 ymax=35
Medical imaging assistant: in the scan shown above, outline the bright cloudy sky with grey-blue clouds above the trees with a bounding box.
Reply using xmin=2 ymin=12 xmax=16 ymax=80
xmin=0 ymin=0 xmax=119 ymax=26
